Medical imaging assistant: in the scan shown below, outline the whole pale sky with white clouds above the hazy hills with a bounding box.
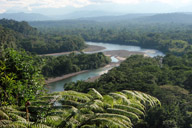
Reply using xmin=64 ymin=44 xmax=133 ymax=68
xmin=0 ymin=0 xmax=192 ymax=15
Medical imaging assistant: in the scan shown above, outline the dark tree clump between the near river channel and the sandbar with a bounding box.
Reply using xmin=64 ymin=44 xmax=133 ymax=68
xmin=42 ymin=52 xmax=110 ymax=77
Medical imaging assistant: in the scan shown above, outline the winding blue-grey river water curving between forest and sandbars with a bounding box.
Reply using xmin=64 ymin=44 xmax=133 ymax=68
xmin=47 ymin=42 xmax=164 ymax=93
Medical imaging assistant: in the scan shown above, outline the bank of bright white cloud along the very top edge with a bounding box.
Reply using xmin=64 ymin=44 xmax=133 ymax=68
xmin=0 ymin=0 xmax=192 ymax=13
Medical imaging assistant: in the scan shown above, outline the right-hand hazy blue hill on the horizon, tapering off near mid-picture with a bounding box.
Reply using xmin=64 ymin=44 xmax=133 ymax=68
xmin=80 ymin=13 xmax=192 ymax=24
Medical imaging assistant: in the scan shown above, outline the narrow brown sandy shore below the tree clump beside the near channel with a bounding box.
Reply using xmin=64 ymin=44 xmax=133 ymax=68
xmin=45 ymin=70 xmax=89 ymax=84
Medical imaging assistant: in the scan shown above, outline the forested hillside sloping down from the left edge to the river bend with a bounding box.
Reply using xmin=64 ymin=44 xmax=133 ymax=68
xmin=0 ymin=19 xmax=85 ymax=54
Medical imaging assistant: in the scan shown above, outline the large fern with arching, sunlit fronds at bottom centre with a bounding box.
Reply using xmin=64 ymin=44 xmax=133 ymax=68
xmin=19 ymin=89 xmax=160 ymax=128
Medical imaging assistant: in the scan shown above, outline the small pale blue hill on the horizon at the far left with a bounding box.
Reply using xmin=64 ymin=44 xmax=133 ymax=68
xmin=0 ymin=12 xmax=51 ymax=21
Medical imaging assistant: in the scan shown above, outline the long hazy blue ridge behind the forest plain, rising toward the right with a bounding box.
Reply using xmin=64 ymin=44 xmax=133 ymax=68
xmin=30 ymin=13 xmax=192 ymax=27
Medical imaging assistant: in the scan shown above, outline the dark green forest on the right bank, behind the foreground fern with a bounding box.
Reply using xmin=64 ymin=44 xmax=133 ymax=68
xmin=64 ymin=53 xmax=192 ymax=128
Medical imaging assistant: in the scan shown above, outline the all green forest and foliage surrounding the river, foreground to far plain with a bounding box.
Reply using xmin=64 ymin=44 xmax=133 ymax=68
xmin=0 ymin=19 xmax=192 ymax=128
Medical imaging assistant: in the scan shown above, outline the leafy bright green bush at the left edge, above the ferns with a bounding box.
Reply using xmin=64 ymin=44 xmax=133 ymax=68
xmin=0 ymin=49 xmax=44 ymax=105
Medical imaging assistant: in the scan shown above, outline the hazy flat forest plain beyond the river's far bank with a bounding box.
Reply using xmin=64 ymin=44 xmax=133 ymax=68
xmin=31 ymin=20 xmax=192 ymax=55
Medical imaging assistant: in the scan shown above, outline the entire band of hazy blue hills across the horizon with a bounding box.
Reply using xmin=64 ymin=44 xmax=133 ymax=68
xmin=0 ymin=11 xmax=192 ymax=25
